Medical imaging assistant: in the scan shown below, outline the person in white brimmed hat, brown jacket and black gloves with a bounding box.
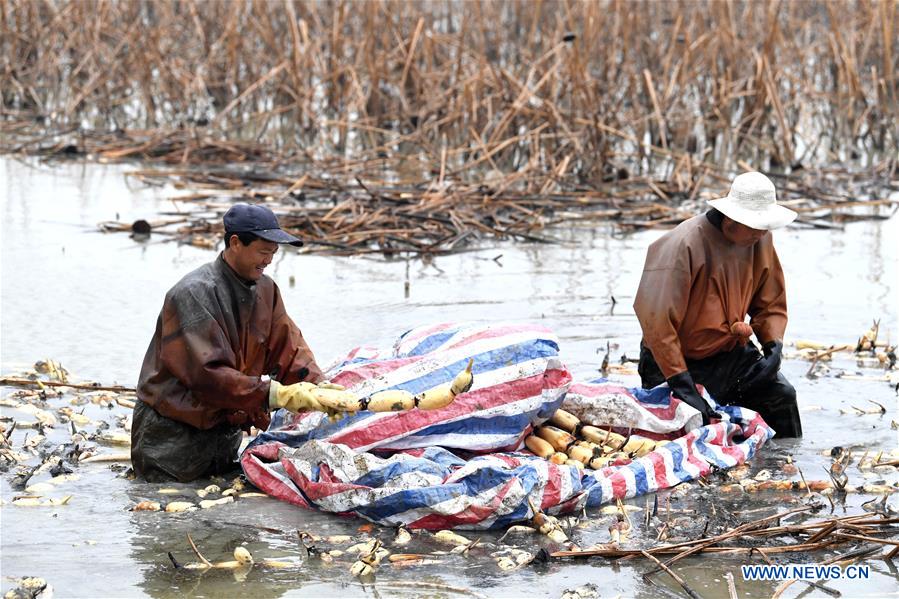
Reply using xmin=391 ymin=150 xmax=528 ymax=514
xmin=634 ymin=172 xmax=802 ymax=437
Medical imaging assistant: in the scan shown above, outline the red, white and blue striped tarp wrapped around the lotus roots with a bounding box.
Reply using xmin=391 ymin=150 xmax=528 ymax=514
xmin=241 ymin=323 xmax=773 ymax=529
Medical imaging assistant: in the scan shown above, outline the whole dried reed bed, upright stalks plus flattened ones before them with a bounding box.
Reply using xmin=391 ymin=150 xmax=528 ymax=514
xmin=0 ymin=0 xmax=899 ymax=253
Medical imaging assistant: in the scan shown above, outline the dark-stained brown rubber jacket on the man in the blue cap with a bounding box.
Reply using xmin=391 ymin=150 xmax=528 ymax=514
xmin=137 ymin=254 xmax=323 ymax=430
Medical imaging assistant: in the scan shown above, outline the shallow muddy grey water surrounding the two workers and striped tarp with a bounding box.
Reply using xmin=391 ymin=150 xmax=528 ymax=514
xmin=0 ymin=159 xmax=899 ymax=597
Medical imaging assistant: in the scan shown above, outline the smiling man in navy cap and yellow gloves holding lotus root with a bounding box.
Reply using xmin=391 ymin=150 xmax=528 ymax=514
xmin=131 ymin=204 xmax=336 ymax=482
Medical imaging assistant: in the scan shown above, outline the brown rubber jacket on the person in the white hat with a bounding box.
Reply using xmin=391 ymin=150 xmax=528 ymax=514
xmin=634 ymin=214 xmax=787 ymax=379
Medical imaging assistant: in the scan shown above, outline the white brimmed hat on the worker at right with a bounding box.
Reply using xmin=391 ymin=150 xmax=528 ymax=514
xmin=708 ymin=172 xmax=798 ymax=230
